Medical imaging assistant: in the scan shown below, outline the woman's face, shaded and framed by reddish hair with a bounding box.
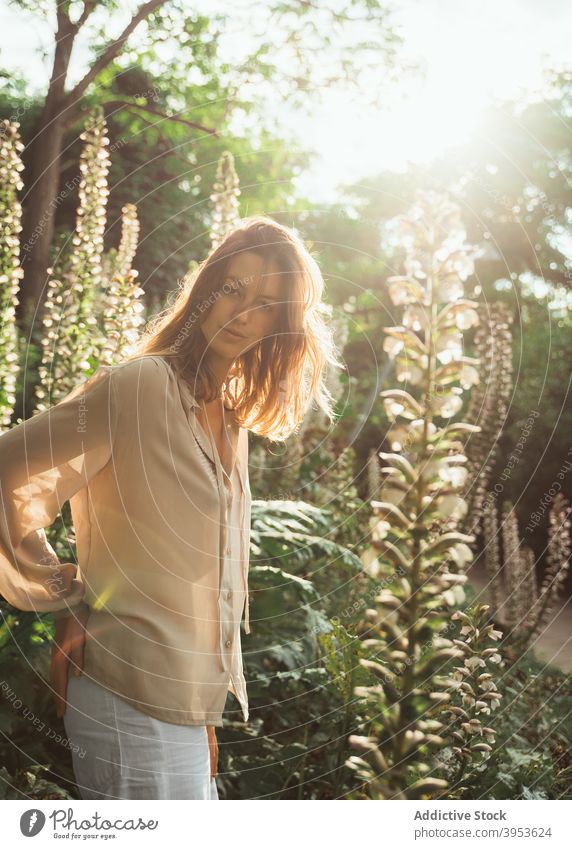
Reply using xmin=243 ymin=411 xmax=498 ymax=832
xmin=201 ymin=252 xmax=287 ymax=360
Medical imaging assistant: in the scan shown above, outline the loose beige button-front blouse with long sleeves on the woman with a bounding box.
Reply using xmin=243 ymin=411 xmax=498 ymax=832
xmin=0 ymin=355 xmax=251 ymax=726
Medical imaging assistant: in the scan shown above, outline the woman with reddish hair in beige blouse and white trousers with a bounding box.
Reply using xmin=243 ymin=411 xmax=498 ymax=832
xmin=0 ymin=216 xmax=340 ymax=799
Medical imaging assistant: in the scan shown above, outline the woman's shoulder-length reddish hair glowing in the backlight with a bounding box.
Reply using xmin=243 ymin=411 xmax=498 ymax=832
xmin=127 ymin=215 xmax=343 ymax=441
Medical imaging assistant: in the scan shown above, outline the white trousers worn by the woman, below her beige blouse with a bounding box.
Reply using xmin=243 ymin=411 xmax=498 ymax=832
xmin=63 ymin=674 xmax=218 ymax=799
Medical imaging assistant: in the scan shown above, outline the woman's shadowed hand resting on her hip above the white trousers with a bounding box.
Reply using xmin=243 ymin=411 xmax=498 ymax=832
xmin=50 ymin=605 xmax=89 ymax=717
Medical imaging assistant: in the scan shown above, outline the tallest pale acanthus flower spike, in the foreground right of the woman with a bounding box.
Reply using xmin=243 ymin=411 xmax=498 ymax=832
xmin=347 ymin=193 xmax=504 ymax=799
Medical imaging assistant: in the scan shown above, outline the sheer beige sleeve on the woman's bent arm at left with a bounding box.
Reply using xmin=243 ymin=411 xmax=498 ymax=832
xmin=0 ymin=366 xmax=117 ymax=619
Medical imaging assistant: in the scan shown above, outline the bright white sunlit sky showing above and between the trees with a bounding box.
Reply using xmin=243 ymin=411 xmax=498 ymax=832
xmin=0 ymin=0 xmax=572 ymax=203
